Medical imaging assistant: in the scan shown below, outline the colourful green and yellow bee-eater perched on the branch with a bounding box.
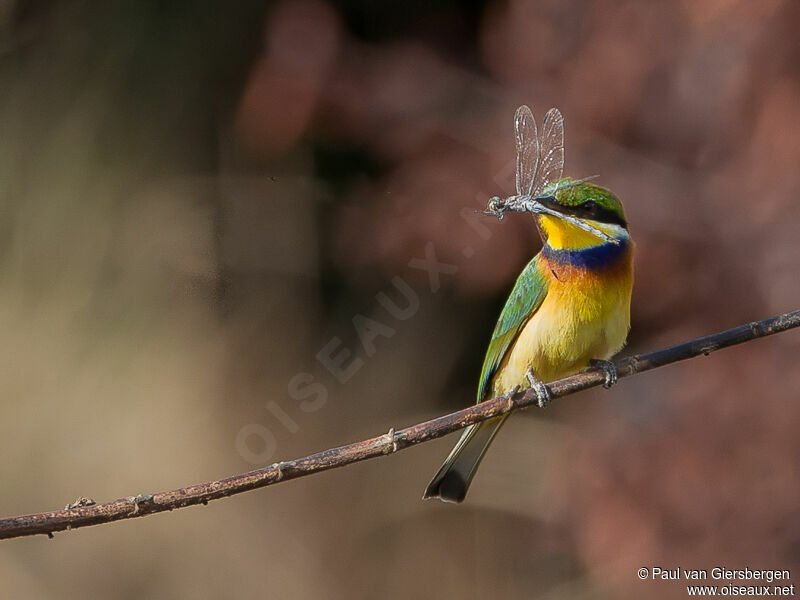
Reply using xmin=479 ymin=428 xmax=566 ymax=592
xmin=423 ymin=178 xmax=634 ymax=503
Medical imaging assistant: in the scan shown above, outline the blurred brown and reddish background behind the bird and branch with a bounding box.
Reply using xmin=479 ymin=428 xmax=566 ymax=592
xmin=0 ymin=0 xmax=800 ymax=600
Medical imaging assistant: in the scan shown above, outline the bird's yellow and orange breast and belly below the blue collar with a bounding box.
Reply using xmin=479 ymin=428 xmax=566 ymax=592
xmin=492 ymin=246 xmax=633 ymax=395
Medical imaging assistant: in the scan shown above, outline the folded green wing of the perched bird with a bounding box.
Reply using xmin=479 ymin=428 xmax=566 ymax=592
xmin=478 ymin=254 xmax=547 ymax=402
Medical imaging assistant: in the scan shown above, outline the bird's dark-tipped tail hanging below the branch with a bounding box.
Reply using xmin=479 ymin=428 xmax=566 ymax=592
xmin=422 ymin=415 xmax=508 ymax=502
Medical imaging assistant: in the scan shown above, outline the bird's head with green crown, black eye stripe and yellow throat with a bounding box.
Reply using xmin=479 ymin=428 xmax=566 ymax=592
xmin=537 ymin=179 xmax=629 ymax=250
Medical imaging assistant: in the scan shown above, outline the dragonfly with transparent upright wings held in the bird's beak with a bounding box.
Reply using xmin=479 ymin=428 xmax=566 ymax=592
xmin=483 ymin=104 xmax=619 ymax=243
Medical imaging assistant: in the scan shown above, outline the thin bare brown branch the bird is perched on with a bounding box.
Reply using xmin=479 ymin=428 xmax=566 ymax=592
xmin=0 ymin=310 xmax=800 ymax=539
